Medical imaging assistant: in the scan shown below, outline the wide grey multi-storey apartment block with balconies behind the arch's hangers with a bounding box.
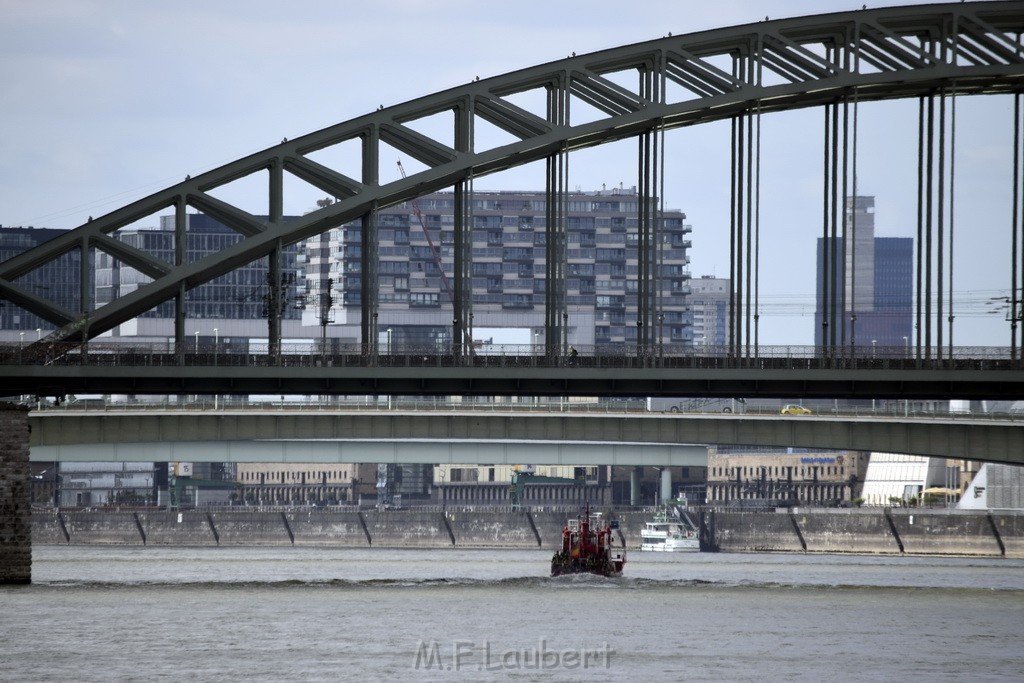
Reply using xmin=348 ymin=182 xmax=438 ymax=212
xmin=303 ymin=188 xmax=693 ymax=348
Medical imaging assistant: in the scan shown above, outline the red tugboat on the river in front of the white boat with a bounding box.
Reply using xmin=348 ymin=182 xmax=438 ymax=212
xmin=551 ymin=508 xmax=626 ymax=577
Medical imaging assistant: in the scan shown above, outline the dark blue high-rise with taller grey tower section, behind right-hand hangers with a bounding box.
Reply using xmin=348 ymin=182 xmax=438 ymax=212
xmin=814 ymin=197 xmax=913 ymax=352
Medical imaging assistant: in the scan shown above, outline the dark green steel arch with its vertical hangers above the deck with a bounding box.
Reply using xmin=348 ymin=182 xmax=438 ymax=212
xmin=0 ymin=2 xmax=1024 ymax=368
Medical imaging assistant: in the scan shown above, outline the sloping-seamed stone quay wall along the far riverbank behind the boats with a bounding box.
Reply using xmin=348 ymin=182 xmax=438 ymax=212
xmin=32 ymin=508 xmax=1024 ymax=558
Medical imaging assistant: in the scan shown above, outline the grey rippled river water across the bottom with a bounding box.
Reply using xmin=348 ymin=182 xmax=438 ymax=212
xmin=0 ymin=546 xmax=1024 ymax=681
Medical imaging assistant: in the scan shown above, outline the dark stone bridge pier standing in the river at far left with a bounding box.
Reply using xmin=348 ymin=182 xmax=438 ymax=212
xmin=0 ymin=402 xmax=32 ymax=584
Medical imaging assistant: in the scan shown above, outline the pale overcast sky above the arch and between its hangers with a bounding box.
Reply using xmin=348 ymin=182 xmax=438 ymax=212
xmin=0 ymin=0 xmax=1012 ymax=345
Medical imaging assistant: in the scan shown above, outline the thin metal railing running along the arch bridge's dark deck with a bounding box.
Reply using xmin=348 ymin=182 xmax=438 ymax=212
xmin=0 ymin=341 xmax=1022 ymax=371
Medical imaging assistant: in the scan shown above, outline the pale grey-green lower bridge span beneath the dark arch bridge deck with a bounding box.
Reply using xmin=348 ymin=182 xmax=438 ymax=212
xmin=24 ymin=410 xmax=1024 ymax=465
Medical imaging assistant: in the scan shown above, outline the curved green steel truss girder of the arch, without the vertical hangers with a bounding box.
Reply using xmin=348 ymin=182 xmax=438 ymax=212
xmin=0 ymin=2 xmax=1024 ymax=348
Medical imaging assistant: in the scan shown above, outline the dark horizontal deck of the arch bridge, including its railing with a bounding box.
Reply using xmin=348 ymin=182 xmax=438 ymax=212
xmin=0 ymin=345 xmax=1024 ymax=399
